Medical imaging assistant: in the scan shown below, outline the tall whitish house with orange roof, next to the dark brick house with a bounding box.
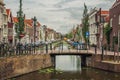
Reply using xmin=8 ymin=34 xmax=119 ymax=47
xmin=89 ymin=8 xmax=109 ymax=49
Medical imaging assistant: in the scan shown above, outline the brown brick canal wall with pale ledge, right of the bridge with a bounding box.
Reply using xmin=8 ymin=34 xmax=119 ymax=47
xmin=86 ymin=54 xmax=120 ymax=72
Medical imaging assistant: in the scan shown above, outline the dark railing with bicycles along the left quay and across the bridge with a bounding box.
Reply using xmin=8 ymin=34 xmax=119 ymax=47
xmin=0 ymin=43 xmax=104 ymax=57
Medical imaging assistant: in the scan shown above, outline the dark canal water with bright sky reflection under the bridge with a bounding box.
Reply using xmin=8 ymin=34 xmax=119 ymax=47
xmin=12 ymin=56 xmax=120 ymax=80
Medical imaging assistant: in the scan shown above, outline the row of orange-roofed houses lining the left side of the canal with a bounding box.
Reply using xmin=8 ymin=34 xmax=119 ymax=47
xmin=0 ymin=0 xmax=60 ymax=45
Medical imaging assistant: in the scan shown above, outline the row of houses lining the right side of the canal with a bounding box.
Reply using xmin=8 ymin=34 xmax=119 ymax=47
xmin=73 ymin=0 xmax=120 ymax=49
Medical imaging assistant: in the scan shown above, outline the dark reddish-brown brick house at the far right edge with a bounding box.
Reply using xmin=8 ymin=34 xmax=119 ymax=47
xmin=109 ymin=0 xmax=120 ymax=49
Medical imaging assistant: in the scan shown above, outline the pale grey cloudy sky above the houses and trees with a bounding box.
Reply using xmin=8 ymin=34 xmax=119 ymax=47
xmin=4 ymin=0 xmax=115 ymax=33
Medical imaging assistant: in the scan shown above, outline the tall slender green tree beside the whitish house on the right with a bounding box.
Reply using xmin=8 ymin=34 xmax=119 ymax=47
xmin=82 ymin=3 xmax=89 ymax=42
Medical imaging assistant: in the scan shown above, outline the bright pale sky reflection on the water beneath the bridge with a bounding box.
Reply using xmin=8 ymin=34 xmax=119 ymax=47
xmin=55 ymin=56 xmax=81 ymax=71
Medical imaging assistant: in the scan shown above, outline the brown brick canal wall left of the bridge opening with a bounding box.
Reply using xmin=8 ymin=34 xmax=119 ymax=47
xmin=0 ymin=54 xmax=52 ymax=80
